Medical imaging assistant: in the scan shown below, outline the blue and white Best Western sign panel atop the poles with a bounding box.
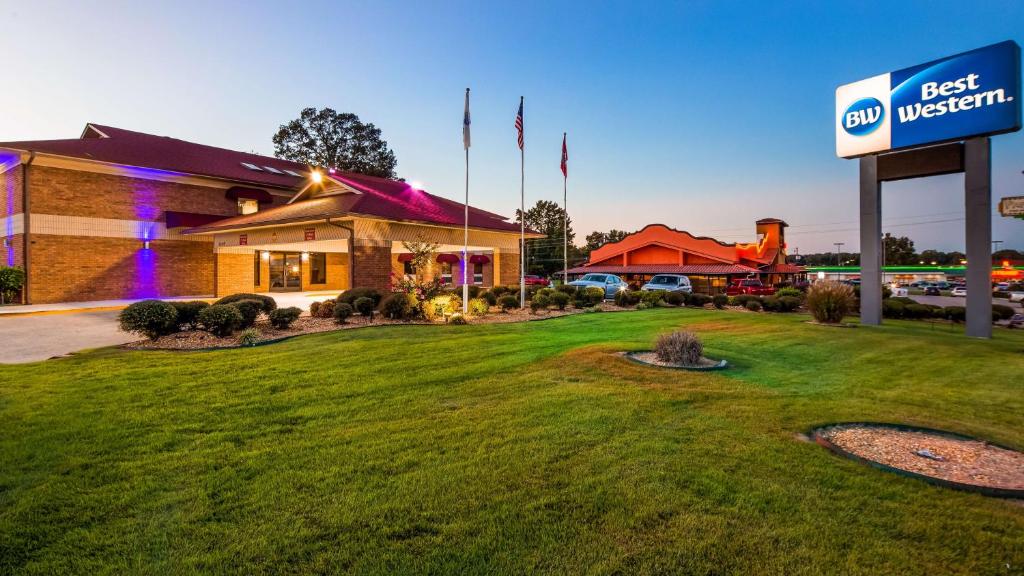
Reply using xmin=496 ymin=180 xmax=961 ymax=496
xmin=836 ymin=40 xmax=1021 ymax=158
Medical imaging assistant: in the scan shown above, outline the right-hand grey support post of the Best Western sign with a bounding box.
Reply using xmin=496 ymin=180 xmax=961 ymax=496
xmin=964 ymin=137 xmax=992 ymax=338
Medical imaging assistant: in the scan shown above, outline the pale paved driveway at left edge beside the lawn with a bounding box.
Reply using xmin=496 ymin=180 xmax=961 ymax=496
xmin=0 ymin=310 xmax=138 ymax=364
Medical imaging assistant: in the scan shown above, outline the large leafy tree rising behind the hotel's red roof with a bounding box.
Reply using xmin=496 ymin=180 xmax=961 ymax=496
xmin=273 ymin=108 xmax=398 ymax=178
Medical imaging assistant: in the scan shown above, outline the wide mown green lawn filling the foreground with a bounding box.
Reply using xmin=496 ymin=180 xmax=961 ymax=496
xmin=0 ymin=308 xmax=1024 ymax=575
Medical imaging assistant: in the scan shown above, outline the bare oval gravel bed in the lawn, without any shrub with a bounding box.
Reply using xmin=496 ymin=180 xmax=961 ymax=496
xmin=812 ymin=422 xmax=1024 ymax=498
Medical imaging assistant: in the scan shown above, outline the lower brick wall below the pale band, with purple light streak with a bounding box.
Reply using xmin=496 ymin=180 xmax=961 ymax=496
xmin=29 ymin=235 xmax=214 ymax=303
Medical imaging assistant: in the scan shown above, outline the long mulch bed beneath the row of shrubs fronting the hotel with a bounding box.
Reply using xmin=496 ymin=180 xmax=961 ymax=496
xmin=128 ymin=302 xmax=632 ymax=351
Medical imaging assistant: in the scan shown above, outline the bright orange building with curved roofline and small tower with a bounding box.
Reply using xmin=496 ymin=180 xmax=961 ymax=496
xmin=568 ymin=218 xmax=804 ymax=294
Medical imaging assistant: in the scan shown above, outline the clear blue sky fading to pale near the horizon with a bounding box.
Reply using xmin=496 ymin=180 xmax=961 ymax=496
xmin=0 ymin=0 xmax=1024 ymax=253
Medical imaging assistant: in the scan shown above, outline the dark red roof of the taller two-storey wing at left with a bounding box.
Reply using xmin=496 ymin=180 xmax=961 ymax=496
xmin=0 ymin=124 xmax=309 ymax=189
